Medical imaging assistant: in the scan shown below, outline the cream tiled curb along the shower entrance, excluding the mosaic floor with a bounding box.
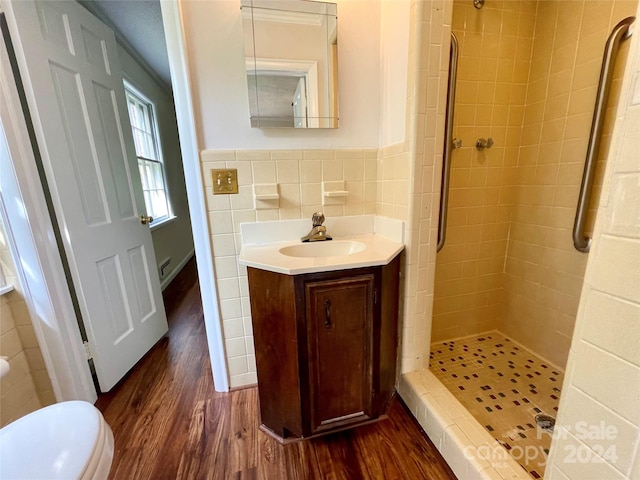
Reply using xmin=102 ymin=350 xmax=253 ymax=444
xmin=398 ymin=370 xmax=531 ymax=480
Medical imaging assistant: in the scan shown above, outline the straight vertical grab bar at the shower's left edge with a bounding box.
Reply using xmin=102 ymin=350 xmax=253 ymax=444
xmin=436 ymin=32 xmax=459 ymax=252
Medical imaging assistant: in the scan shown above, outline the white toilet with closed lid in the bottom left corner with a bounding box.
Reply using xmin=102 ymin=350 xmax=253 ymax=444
xmin=0 ymin=401 xmax=113 ymax=480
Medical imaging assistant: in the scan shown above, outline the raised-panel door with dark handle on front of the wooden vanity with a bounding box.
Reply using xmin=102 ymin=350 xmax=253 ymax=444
xmin=305 ymin=273 xmax=376 ymax=433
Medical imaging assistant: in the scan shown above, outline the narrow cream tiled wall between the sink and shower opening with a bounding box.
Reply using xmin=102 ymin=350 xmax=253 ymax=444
xmin=392 ymin=0 xmax=453 ymax=372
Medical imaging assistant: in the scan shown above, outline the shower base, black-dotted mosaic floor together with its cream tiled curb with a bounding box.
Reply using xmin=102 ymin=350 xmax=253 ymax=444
xmin=399 ymin=331 xmax=563 ymax=480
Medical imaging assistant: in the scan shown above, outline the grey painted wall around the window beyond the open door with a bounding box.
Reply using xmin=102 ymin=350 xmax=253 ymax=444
xmin=118 ymin=44 xmax=193 ymax=288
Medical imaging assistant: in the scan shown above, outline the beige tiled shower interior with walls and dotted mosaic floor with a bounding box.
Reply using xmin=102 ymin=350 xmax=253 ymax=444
xmin=422 ymin=0 xmax=637 ymax=478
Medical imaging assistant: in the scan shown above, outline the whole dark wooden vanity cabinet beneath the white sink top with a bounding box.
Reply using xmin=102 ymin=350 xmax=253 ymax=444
xmin=248 ymin=256 xmax=400 ymax=441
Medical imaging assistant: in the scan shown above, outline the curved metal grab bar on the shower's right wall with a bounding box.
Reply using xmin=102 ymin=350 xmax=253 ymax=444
xmin=573 ymin=17 xmax=636 ymax=253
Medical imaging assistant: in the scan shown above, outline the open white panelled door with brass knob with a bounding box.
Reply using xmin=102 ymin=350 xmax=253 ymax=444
xmin=2 ymin=0 xmax=167 ymax=391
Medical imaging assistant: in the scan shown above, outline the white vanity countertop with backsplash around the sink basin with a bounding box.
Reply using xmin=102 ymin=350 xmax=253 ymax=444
xmin=239 ymin=215 xmax=404 ymax=275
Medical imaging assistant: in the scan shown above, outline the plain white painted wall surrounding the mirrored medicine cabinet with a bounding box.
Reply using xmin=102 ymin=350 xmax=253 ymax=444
xmin=182 ymin=0 xmax=384 ymax=149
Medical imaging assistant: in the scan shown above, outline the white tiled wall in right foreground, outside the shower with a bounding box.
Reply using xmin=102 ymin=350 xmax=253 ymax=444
xmin=545 ymin=3 xmax=640 ymax=474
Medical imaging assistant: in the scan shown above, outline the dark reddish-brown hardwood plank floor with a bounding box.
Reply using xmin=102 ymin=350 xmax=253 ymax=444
xmin=96 ymin=261 xmax=456 ymax=480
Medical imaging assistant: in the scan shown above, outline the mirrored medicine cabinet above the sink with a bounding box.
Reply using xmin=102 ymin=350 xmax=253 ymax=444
xmin=242 ymin=0 xmax=338 ymax=128
